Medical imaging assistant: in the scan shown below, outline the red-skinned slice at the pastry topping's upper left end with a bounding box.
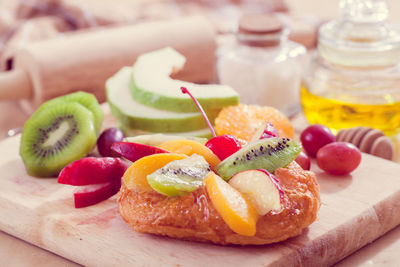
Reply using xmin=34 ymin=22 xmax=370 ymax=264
xmin=111 ymin=142 xmax=168 ymax=162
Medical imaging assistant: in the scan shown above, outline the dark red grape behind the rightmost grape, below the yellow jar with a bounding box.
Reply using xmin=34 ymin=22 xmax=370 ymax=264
xmin=300 ymin=124 xmax=336 ymax=157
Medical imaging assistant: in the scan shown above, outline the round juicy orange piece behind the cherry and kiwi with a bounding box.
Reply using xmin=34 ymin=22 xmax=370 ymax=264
xmin=215 ymin=104 xmax=294 ymax=141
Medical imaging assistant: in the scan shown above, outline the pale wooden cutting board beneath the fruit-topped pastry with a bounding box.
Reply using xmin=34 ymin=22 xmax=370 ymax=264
xmin=0 ymin=136 xmax=400 ymax=266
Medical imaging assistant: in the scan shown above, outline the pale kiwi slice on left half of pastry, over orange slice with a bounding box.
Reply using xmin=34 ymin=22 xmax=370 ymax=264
xmin=147 ymin=154 xmax=211 ymax=197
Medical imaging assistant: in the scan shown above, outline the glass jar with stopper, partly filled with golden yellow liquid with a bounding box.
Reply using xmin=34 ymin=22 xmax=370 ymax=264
xmin=300 ymin=0 xmax=400 ymax=136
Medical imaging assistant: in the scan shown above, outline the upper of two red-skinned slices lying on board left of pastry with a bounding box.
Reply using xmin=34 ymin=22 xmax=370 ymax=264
xmin=58 ymin=157 xmax=128 ymax=185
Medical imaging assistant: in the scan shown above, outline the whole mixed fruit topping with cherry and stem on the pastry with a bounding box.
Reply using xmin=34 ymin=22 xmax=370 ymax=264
xmin=115 ymin=88 xmax=302 ymax=236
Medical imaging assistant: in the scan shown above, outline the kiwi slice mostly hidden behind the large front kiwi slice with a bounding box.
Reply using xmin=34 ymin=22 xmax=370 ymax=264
xmin=36 ymin=91 xmax=104 ymax=134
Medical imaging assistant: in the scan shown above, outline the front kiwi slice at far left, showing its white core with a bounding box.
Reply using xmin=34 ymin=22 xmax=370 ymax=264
xmin=20 ymin=102 xmax=96 ymax=177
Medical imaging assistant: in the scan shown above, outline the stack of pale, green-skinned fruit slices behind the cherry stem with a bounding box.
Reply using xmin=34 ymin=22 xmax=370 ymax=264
xmin=106 ymin=48 xmax=239 ymax=137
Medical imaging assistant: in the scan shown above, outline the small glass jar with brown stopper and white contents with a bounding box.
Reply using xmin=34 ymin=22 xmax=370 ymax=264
xmin=217 ymin=14 xmax=306 ymax=113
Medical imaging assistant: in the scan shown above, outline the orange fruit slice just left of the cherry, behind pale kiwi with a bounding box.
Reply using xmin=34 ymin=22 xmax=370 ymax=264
xmin=157 ymin=140 xmax=221 ymax=168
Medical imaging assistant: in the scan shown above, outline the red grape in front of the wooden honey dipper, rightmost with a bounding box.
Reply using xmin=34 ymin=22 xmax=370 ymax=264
xmin=317 ymin=142 xmax=361 ymax=175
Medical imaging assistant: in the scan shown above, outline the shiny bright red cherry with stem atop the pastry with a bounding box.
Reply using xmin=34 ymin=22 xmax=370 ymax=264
xmin=206 ymin=134 xmax=242 ymax=160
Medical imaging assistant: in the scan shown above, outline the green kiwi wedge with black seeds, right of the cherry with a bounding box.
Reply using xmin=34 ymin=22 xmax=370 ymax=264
xmin=215 ymin=137 xmax=302 ymax=180
